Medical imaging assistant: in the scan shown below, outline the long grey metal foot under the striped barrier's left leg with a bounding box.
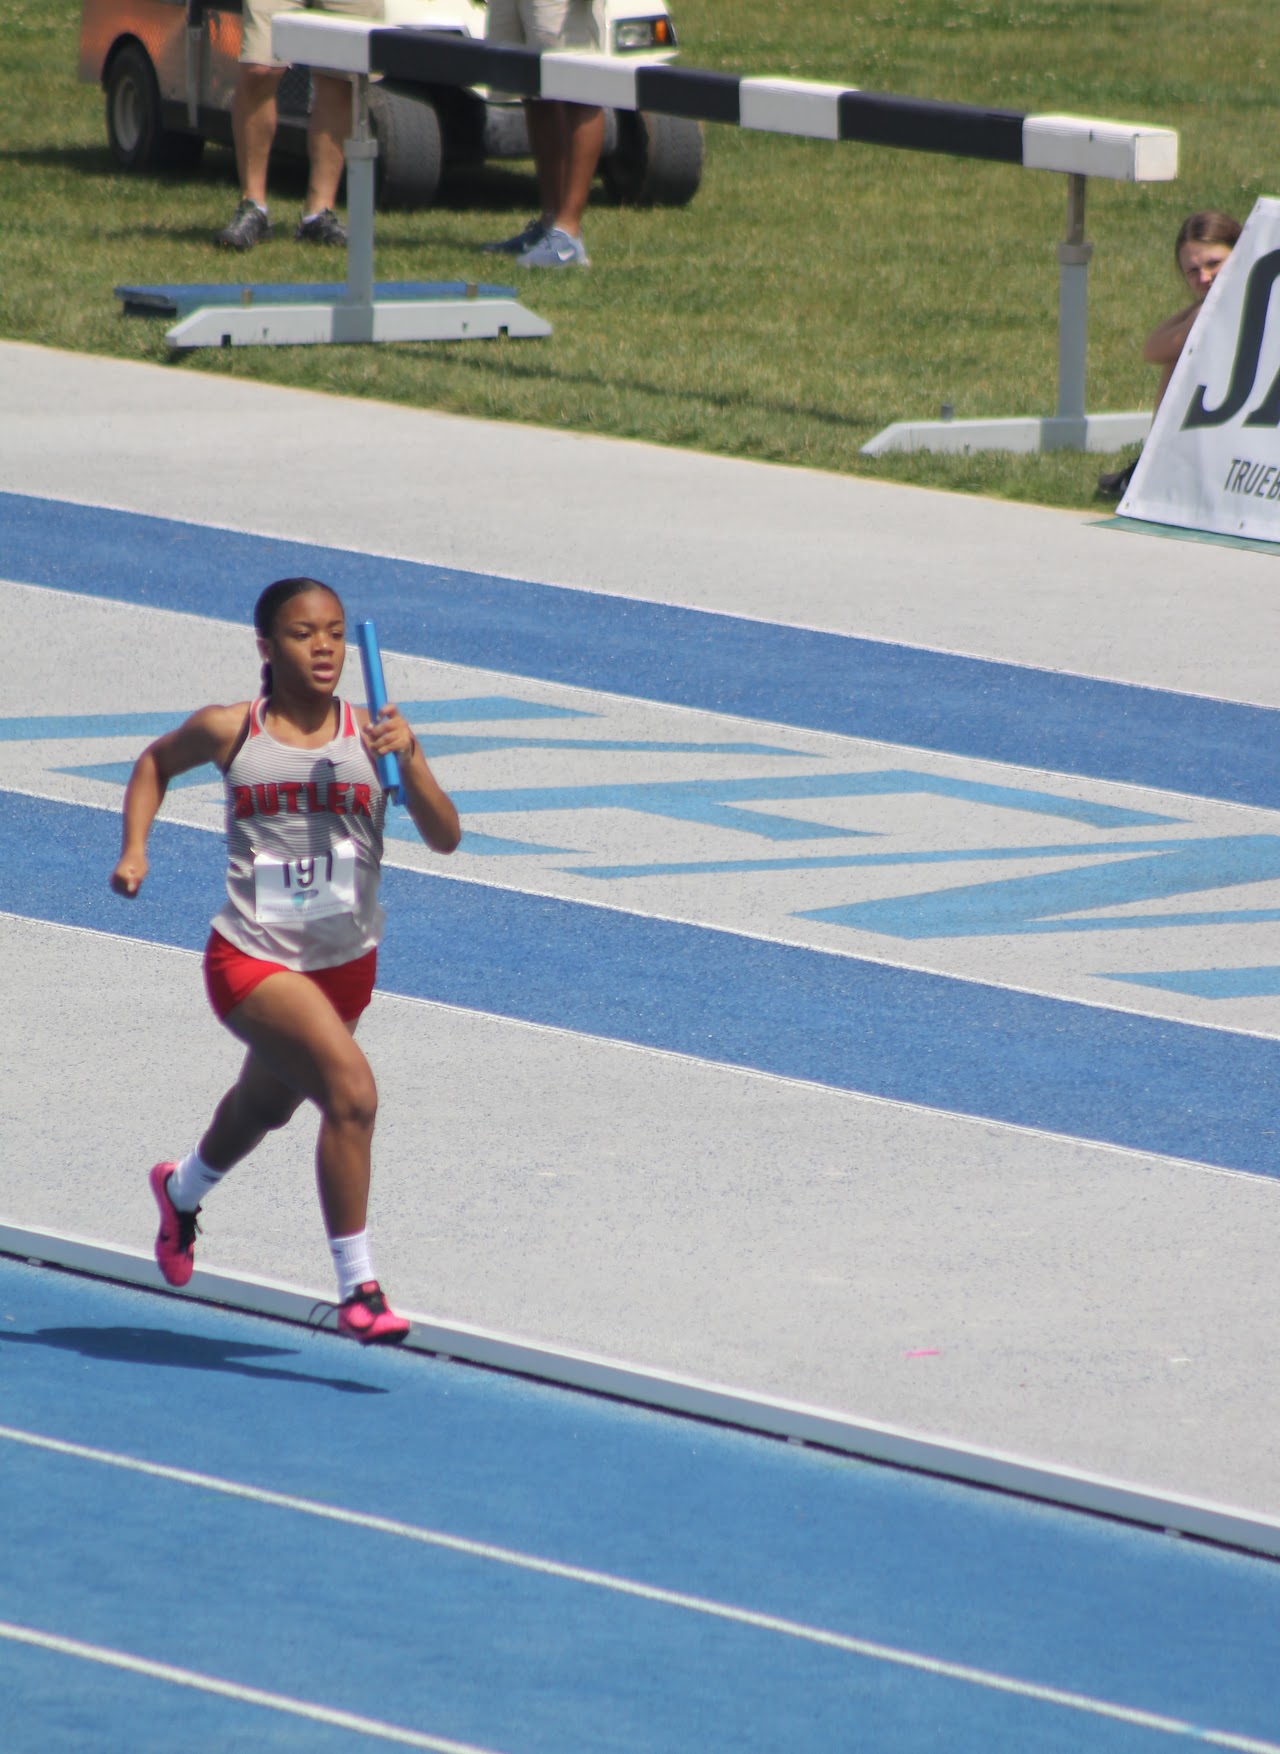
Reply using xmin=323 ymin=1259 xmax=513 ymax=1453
xmin=165 ymin=298 xmax=551 ymax=353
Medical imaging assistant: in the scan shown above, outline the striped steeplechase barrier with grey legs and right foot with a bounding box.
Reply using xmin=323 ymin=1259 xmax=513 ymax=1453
xmin=252 ymin=12 xmax=1178 ymax=456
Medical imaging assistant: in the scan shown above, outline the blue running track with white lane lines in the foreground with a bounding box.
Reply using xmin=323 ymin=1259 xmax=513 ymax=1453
xmin=0 ymin=1261 xmax=1280 ymax=1754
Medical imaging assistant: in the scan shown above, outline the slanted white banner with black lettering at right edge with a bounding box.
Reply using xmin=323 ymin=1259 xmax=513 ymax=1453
xmin=1119 ymin=196 xmax=1280 ymax=542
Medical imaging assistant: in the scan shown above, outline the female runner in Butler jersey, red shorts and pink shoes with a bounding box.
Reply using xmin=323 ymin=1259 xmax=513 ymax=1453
xmin=110 ymin=579 xmax=461 ymax=1344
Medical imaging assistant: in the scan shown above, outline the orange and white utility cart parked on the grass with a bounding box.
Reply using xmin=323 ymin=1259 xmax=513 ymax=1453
xmin=79 ymin=0 xmax=703 ymax=207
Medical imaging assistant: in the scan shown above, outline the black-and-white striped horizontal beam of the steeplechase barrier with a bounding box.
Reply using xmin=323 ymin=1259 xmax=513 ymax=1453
xmin=272 ymin=14 xmax=1178 ymax=182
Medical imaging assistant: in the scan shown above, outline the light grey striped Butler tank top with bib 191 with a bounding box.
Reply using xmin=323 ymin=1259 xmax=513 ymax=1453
xmin=212 ymin=700 xmax=388 ymax=970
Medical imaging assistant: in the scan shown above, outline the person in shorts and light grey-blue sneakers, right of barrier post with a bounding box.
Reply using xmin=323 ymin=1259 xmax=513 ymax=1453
xmin=484 ymin=0 xmax=605 ymax=268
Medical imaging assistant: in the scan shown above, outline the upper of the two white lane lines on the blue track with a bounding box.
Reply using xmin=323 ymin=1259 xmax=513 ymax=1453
xmin=0 ymin=1424 xmax=1280 ymax=1754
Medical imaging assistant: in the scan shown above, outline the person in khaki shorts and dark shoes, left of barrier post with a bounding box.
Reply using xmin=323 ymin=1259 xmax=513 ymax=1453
xmin=214 ymin=0 xmax=384 ymax=249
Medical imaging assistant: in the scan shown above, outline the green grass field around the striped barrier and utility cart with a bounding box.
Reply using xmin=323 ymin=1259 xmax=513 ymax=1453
xmin=0 ymin=0 xmax=1255 ymax=507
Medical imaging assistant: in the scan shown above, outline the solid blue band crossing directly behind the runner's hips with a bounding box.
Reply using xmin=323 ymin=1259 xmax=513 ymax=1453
xmin=0 ymin=791 xmax=1280 ymax=1175
